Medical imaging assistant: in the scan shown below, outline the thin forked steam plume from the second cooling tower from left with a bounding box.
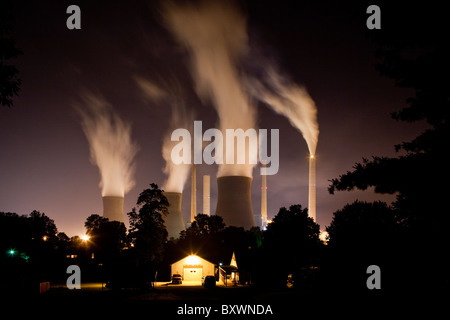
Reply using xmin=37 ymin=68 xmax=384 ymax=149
xmin=135 ymin=77 xmax=194 ymax=193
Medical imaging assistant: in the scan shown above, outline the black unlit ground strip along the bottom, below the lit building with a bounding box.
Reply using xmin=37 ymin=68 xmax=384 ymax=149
xmin=1 ymin=284 xmax=436 ymax=319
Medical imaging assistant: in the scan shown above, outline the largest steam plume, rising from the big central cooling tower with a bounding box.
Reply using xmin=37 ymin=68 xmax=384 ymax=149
xmin=164 ymin=1 xmax=256 ymax=177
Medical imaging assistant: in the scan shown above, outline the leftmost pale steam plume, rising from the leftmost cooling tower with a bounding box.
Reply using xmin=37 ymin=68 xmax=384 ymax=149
xmin=75 ymin=92 xmax=139 ymax=197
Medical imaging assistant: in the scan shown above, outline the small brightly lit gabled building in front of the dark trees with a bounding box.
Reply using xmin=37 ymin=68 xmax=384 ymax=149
xmin=170 ymin=255 xmax=215 ymax=281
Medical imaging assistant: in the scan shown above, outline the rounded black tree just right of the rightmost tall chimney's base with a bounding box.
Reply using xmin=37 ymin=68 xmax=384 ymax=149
xmin=323 ymin=201 xmax=401 ymax=291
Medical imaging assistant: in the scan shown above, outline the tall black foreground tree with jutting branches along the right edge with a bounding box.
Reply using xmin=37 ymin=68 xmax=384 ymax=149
xmin=329 ymin=3 xmax=450 ymax=288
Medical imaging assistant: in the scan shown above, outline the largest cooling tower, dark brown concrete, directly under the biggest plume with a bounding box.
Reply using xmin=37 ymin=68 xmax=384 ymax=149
xmin=216 ymin=176 xmax=255 ymax=229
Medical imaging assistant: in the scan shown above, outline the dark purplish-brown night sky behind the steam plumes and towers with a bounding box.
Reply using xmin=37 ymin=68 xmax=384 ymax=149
xmin=0 ymin=1 xmax=425 ymax=236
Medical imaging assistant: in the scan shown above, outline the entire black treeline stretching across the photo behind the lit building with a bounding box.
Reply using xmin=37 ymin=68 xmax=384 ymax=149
xmin=0 ymin=190 xmax=448 ymax=293
